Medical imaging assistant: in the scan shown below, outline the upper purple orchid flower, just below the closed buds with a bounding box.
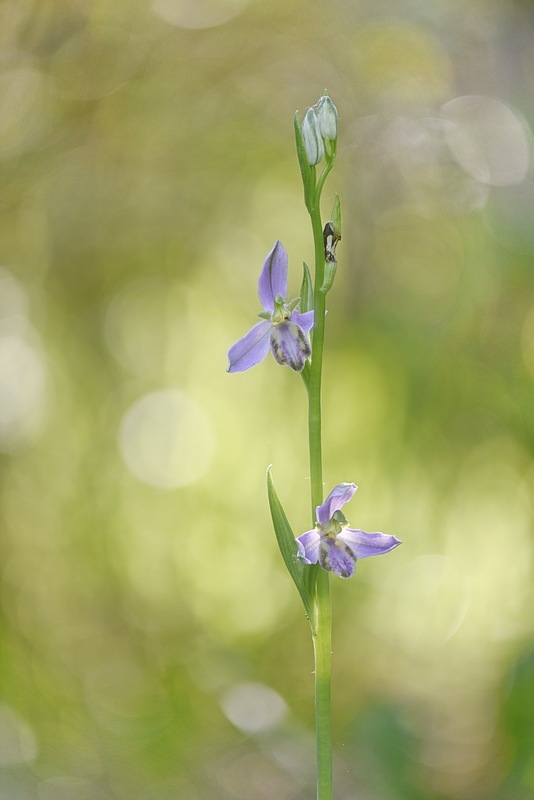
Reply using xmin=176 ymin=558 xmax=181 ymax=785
xmin=228 ymin=241 xmax=314 ymax=372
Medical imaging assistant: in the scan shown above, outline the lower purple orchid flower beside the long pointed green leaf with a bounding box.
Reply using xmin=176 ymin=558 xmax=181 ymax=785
xmin=297 ymin=483 xmax=402 ymax=578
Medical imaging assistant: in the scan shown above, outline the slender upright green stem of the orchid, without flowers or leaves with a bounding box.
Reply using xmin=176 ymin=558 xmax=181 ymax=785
xmin=308 ymin=181 xmax=332 ymax=800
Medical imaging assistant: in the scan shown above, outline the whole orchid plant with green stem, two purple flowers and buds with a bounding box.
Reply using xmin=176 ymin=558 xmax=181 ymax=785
xmin=228 ymin=95 xmax=400 ymax=800
